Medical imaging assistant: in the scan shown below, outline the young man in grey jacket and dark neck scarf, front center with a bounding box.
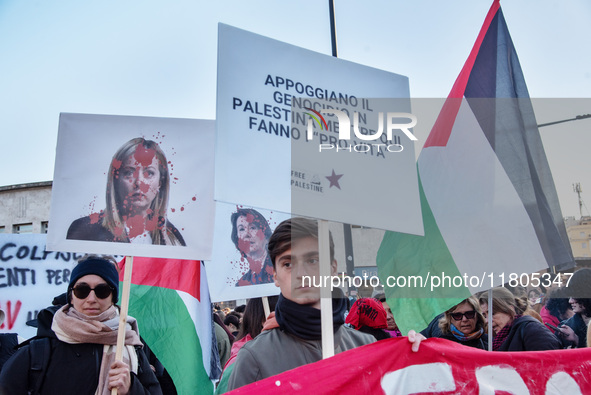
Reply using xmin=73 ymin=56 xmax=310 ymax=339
xmin=228 ymin=218 xmax=423 ymax=390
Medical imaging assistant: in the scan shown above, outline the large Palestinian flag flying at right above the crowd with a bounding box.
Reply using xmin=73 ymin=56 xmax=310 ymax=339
xmin=377 ymin=0 xmax=574 ymax=332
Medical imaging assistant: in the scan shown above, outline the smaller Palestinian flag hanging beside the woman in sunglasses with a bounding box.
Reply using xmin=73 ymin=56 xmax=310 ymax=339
xmin=119 ymin=257 xmax=213 ymax=394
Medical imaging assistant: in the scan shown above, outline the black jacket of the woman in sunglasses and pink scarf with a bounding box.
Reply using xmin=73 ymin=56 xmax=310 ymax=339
xmin=0 ymin=306 xmax=162 ymax=395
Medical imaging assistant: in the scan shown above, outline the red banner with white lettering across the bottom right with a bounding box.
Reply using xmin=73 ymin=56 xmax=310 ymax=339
xmin=231 ymin=338 xmax=591 ymax=395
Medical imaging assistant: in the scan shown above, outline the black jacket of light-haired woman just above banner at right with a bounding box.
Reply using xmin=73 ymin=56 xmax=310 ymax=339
xmin=498 ymin=315 xmax=562 ymax=351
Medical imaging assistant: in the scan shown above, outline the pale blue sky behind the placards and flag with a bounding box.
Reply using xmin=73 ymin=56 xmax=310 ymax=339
xmin=0 ymin=0 xmax=591 ymax=216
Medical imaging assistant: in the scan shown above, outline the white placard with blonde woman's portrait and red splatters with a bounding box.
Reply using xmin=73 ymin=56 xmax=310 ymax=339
xmin=47 ymin=114 xmax=214 ymax=259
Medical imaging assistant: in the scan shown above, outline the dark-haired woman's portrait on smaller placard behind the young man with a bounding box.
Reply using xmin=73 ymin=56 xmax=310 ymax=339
xmin=230 ymin=208 xmax=273 ymax=287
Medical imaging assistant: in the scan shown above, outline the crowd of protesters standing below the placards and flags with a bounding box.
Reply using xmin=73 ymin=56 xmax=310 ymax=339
xmin=0 ymin=218 xmax=591 ymax=394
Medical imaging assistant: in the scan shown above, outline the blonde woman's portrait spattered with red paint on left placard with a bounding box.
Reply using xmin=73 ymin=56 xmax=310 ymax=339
xmin=66 ymin=137 xmax=185 ymax=246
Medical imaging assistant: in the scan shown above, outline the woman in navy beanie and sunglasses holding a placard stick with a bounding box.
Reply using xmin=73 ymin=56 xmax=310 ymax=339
xmin=0 ymin=256 xmax=162 ymax=395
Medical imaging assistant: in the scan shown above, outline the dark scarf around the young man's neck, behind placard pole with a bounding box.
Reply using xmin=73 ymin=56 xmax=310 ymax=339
xmin=275 ymin=292 xmax=347 ymax=340
